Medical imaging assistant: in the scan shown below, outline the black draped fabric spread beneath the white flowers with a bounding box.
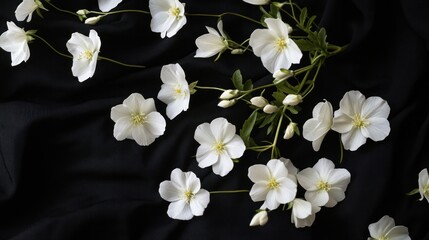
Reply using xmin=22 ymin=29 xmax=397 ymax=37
xmin=0 ymin=0 xmax=429 ymax=240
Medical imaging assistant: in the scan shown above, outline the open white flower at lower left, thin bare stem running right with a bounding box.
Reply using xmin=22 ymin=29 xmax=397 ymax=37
xmin=159 ymin=168 xmax=210 ymax=220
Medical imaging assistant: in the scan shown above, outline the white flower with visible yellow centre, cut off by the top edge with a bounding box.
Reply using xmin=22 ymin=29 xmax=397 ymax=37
xmin=149 ymin=0 xmax=186 ymax=38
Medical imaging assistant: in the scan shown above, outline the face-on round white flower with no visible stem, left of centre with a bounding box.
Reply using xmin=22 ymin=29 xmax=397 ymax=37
xmin=110 ymin=93 xmax=166 ymax=146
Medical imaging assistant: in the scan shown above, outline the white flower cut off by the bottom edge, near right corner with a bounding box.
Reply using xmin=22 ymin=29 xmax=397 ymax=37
xmin=368 ymin=215 xmax=411 ymax=240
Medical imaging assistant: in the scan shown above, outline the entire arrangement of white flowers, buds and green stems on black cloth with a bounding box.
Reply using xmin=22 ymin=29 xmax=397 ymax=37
xmin=0 ymin=0 xmax=414 ymax=236
